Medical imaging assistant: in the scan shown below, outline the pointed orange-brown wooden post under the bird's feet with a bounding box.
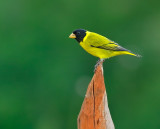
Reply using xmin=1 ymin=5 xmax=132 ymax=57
xmin=77 ymin=63 xmax=115 ymax=129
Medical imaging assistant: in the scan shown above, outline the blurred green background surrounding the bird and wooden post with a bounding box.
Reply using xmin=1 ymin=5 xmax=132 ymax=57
xmin=0 ymin=0 xmax=160 ymax=129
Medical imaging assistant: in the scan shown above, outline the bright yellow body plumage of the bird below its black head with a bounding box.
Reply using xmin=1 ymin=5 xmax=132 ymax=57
xmin=80 ymin=31 xmax=136 ymax=59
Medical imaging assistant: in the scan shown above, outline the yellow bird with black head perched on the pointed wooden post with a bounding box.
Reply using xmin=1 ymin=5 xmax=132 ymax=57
xmin=69 ymin=29 xmax=140 ymax=70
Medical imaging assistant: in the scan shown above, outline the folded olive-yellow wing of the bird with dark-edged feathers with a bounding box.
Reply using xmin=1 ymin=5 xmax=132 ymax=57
xmin=87 ymin=34 xmax=128 ymax=51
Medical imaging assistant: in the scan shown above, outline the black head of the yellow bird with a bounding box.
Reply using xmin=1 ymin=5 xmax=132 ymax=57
xmin=69 ymin=29 xmax=86 ymax=42
